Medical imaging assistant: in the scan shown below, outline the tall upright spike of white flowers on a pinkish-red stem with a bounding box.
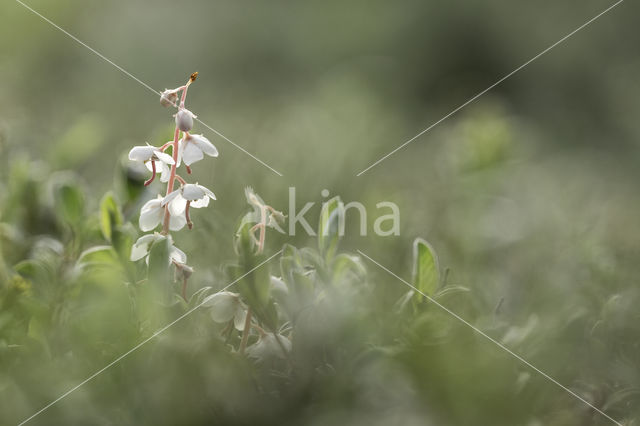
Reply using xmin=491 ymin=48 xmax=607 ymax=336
xmin=129 ymin=73 xmax=218 ymax=299
